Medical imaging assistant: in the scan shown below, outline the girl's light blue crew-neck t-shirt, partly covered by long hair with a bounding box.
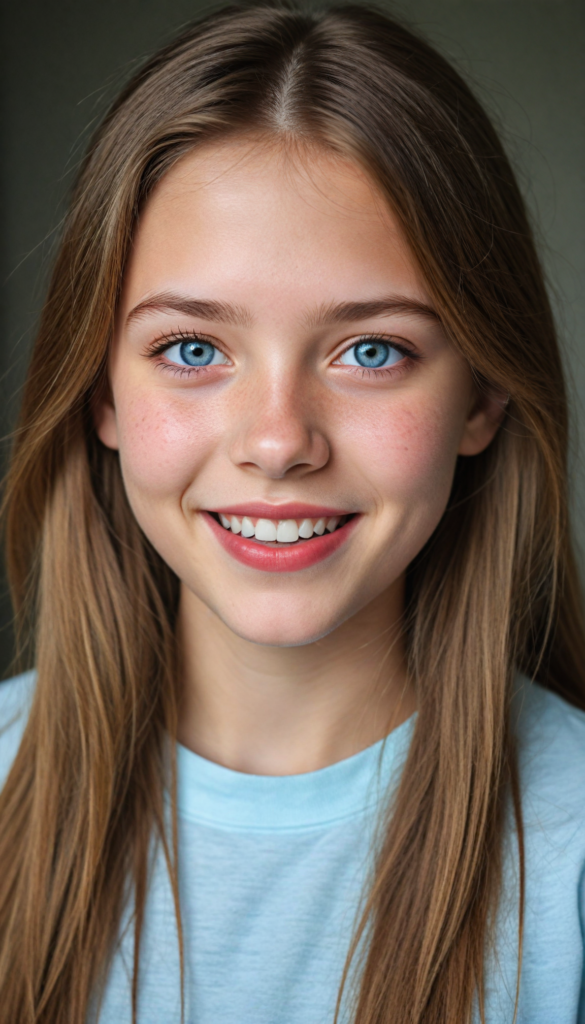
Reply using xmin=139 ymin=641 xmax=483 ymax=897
xmin=0 ymin=676 xmax=585 ymax=1024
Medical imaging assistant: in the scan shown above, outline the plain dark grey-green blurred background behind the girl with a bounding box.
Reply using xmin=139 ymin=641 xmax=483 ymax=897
xmin=0 ymin=0 xmax=585 ymax=678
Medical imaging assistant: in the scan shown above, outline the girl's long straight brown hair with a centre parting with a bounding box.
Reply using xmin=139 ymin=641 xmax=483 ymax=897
xmin=0 ymin=5 xmax=585 ymax=1024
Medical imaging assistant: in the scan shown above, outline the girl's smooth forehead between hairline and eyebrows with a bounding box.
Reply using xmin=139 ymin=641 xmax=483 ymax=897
xmin=123 ymin=139 xmax=427 ymax=315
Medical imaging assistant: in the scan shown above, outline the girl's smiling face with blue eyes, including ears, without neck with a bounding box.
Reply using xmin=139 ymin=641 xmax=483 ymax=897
xmin=95 ymin=140 xmax=498 ymax=645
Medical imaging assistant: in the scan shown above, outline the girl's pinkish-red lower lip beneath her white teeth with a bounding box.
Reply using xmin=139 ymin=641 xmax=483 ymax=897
xmin=202 ymin=512 xmax=361 ymax=572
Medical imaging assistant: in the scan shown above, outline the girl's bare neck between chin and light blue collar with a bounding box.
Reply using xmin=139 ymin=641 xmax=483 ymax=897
xmin=178 ymin=586 xmax=415 ymax=775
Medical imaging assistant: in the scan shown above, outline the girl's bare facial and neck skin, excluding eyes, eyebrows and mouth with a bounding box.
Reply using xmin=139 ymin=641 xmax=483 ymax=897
xmin=95 ymin=139 xmax=501 ymax=774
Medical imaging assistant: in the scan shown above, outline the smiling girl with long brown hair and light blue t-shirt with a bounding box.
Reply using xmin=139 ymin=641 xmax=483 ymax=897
xmin=0 ymin=5 xmax=585 ymax=1024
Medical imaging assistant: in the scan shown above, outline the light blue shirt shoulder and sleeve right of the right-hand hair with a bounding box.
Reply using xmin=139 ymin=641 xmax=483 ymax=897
xmin=499 ymin=677 xmax=585 ymax=1024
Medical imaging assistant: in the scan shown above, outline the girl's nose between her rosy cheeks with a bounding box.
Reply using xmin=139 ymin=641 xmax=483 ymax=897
xmin=231 ymin=381 xmax=330 ymax=480
